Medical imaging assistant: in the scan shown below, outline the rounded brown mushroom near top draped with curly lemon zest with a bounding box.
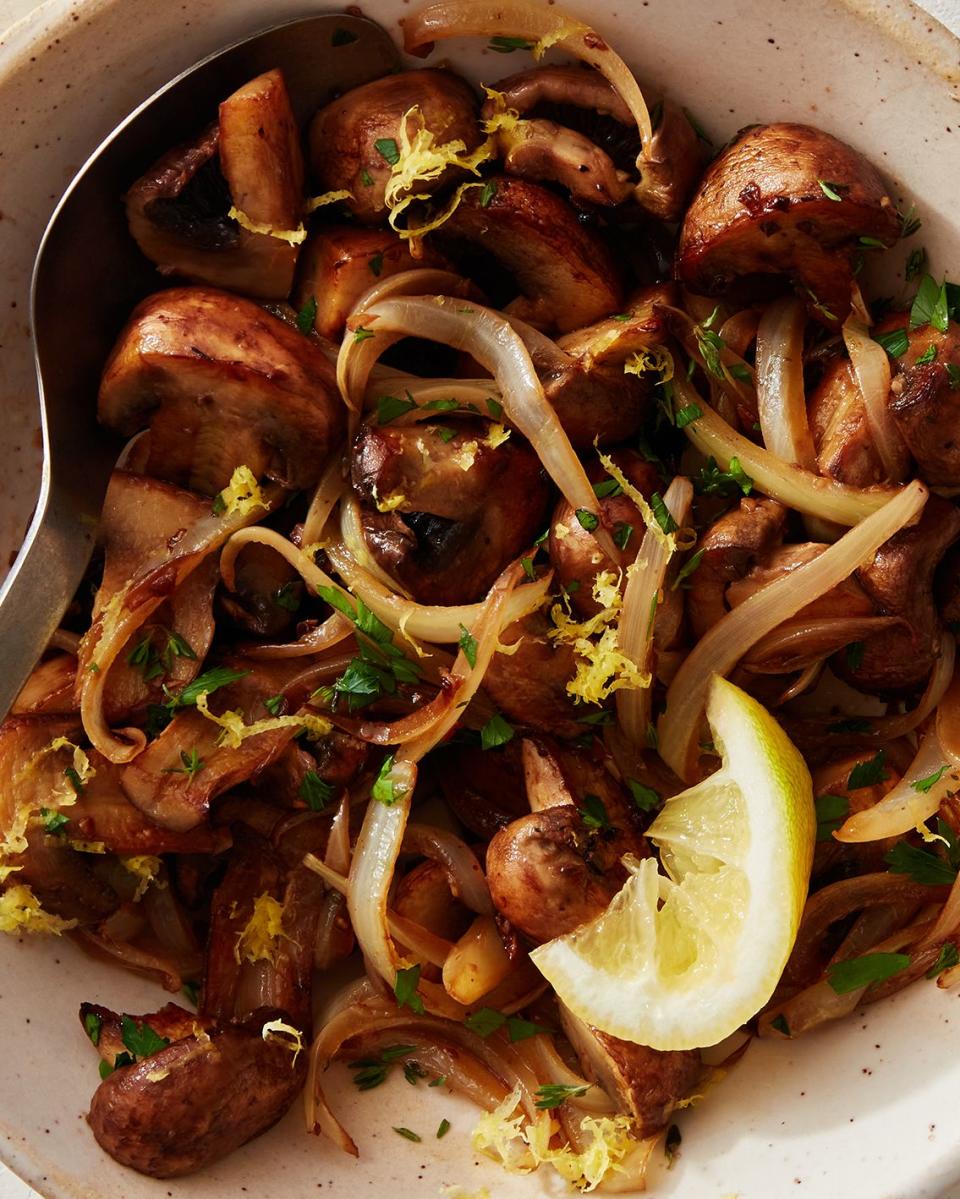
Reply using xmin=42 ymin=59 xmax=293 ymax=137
xmin=309 ymin=71 xmax=482 ymax=224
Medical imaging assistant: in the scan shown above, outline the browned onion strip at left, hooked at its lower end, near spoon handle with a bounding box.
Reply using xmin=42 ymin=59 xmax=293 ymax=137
xmin=78 ymin=484 xmax=282 ymax=763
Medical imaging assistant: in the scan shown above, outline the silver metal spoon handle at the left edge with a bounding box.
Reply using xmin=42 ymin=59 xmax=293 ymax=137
xmin=0 ymin=492 xmax=96 ymax=719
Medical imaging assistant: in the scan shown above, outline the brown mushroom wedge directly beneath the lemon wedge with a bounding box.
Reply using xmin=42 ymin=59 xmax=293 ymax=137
xmin=560 ymin=1005 xmax=704 ymax=1137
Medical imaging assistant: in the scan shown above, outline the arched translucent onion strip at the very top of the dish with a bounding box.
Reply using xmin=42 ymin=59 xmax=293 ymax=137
xmin=401 ymin=0 xmax=653 ymax=158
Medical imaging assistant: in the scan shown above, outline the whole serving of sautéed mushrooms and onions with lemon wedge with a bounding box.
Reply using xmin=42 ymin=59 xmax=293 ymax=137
xmin=0 ymin=2 xmax=960 ymax=1189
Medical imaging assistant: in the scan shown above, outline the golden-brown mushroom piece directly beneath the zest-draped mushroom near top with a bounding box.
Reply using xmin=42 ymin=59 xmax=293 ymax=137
xmin=294 ymin=225 xmax=447 ymax=341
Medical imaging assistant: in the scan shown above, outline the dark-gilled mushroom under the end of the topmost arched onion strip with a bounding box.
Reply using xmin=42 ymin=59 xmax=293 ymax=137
xmin=483 ymin=66 xmax=704 ymax=221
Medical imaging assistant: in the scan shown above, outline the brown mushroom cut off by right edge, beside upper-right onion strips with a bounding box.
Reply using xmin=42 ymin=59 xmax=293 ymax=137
xmin=889 ymin=321 xmax=960 ymax=488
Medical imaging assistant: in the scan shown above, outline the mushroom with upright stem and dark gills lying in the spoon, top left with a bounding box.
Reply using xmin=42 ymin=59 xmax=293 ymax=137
xmin=126 ymin=71 xmax=303 ymax=300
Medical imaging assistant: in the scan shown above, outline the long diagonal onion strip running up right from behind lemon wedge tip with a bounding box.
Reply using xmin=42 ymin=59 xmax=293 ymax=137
xmin=659 ymin=481 xmax=928 ymax=782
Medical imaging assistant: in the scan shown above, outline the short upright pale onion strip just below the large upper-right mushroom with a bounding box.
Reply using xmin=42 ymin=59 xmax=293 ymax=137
xmin=756 ymin=296 xmax=814 ymax=472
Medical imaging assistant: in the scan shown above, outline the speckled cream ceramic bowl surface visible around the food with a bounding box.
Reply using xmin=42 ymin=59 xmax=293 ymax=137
xmin=0 ymin=0 xmax=960 ymax=1199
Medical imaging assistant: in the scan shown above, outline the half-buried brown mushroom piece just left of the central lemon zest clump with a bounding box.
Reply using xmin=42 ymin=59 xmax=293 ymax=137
xmin=483 ymin=613 xmax=587 ymax=739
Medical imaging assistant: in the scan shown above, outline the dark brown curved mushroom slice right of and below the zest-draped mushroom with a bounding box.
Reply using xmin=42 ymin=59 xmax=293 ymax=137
xmin=439 ymin=175 xmax=623 ymax=333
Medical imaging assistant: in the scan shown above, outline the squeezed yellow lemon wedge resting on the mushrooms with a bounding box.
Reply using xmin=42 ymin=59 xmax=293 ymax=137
xmin=531 ymin=677 xmax=816 ymax=1049
